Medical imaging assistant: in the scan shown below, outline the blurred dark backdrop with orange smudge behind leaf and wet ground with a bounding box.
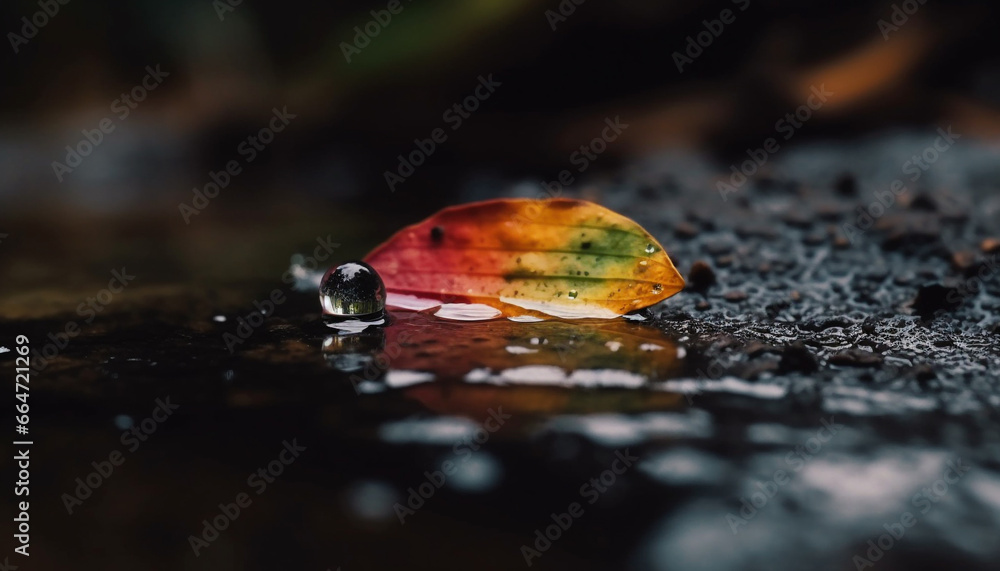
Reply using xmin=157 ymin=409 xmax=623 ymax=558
xmin=0 ymin=0 xmax=1000 ymax=300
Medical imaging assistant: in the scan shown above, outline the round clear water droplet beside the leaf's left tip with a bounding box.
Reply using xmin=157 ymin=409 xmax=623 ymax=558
xmin=319 ymin=262 xmax=385 ymax=317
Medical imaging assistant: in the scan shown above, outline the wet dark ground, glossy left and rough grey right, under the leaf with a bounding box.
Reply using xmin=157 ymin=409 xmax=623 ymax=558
xmin=0 ymin=138 xmax=1000 ymax=570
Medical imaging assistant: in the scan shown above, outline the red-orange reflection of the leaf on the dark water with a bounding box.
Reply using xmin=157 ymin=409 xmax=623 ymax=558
xmin=322 ymin=308 xmax=683 ymax=416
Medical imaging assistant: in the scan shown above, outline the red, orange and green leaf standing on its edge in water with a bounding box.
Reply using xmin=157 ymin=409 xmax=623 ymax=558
xmin=365 ymin=199 xmax=684 ymax=318
